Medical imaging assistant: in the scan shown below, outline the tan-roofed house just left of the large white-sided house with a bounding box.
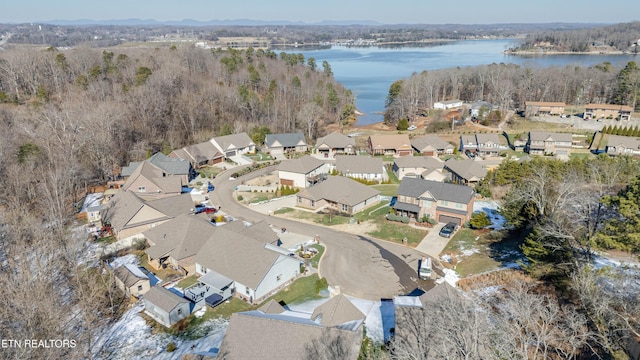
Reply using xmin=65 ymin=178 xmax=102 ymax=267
xmin=143 ymin=214 xmax=218 ymax=275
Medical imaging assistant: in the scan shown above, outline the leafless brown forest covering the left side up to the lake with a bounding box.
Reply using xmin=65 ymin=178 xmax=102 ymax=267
xmin=0 ymin=47 xmax=353 ymax=359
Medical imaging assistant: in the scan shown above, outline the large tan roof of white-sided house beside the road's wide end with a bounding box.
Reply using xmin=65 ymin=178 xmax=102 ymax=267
xmin=196 ymin=225 xmax=288 ymax=289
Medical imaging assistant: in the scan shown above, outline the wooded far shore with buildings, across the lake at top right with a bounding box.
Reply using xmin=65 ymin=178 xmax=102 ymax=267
xmin=512 ymin=22 xmax=640 ymax=54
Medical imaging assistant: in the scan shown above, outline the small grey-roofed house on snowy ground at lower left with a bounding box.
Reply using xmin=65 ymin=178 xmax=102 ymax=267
xmin=144 ymin=285 xmax=191 ymax=327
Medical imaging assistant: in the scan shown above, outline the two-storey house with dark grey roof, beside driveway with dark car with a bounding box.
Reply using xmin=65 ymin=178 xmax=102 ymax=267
xmin=393 ymin=177 xmax=475 ymax=225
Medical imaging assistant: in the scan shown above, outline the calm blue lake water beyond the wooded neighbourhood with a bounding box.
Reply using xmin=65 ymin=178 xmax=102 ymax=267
xmin=286 ymin=39 xmax=640 ymax=125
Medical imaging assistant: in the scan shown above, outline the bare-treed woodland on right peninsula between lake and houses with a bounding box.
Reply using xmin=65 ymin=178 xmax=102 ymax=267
xmin=385 ymin=61 xmax=640 ymax=123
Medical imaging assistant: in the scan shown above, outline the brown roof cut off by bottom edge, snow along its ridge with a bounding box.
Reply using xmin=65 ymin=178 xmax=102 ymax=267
xmin=218 ymin=310 xmax=362 ymax=360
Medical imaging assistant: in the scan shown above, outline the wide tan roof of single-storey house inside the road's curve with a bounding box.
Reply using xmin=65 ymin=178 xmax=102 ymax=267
xmin=298 ymin=176 xmax=380 ymax=206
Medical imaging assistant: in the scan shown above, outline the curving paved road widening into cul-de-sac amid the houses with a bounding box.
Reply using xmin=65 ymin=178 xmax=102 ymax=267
xmin=210 ymin=167 xmax=433 ymax=300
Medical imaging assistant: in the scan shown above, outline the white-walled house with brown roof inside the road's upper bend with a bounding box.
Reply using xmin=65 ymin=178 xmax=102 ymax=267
xmin=278 ymin=155 xmax=329 ymax=188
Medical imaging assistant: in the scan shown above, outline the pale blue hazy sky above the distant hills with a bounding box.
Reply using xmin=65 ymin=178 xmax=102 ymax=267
xmin=0 ymin=0 xmax=640 ymax=24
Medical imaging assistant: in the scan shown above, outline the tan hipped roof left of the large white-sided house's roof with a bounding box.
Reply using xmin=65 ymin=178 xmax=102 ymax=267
xmin=143 ymin=214 xmax=217 ymax=260
